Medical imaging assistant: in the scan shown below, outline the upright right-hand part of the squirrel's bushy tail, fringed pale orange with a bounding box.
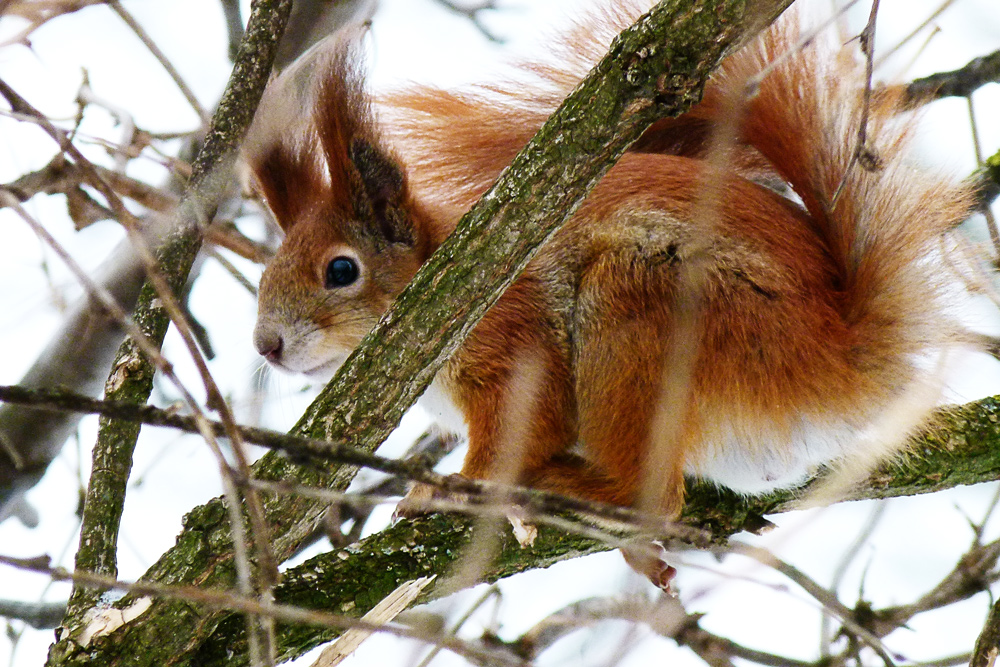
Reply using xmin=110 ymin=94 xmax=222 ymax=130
xmin=708 ymin=17 xmax=973 ymax=386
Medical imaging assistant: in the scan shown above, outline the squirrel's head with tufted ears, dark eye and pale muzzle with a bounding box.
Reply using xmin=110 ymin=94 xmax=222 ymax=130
xmin=244 ymin=29 xmax=427 ymax=376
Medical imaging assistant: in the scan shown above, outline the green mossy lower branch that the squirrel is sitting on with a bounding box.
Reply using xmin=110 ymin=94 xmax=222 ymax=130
xmin=150 ymin=397 xmax=1000 ymax=667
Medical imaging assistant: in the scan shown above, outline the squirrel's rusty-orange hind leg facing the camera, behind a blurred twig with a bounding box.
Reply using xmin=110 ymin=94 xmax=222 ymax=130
xmin=576 ymin=249 xmax=697 ymax=520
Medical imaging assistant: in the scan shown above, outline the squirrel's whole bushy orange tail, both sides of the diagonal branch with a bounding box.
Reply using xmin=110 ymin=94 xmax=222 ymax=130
xmin=381 ymin=0 xmax=972 ymax=380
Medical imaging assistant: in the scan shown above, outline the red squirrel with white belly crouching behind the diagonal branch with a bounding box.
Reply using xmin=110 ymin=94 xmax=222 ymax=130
xmin=245 ymin=2 xmax=972 ymax=544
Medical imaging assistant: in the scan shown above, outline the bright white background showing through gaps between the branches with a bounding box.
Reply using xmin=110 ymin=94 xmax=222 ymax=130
xmin=0 ymin=0 xmax=1000 ymax=666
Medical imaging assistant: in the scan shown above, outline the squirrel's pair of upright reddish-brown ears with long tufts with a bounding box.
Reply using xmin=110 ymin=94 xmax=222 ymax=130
xmin=244 ymin=27 xmax=416 ymax=246
